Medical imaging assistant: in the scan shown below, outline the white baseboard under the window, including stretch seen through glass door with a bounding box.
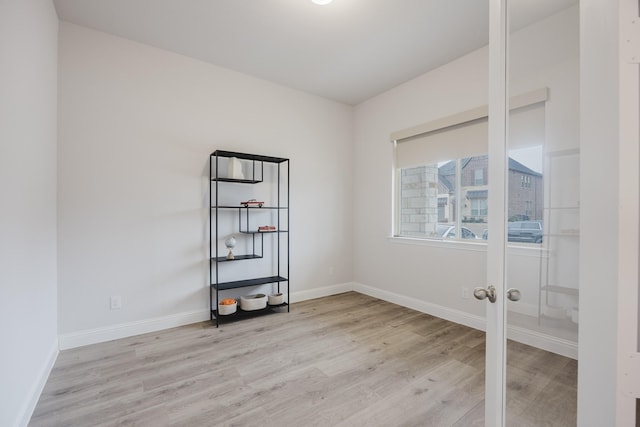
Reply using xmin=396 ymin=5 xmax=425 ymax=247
xmin=353 ymin=283 xmax=578 ymax=359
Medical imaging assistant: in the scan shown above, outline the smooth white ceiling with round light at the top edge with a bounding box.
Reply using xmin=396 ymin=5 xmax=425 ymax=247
xmin=54 ymin=0 xmax=577 ymax=105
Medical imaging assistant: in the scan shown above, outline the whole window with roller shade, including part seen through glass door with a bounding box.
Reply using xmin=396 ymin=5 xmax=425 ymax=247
xmin=391 ymin=90 xmax=547 ymax=244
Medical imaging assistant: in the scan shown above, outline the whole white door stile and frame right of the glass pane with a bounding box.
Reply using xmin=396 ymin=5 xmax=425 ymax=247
xmin=578 ymin=0 xmax=640 ymax=427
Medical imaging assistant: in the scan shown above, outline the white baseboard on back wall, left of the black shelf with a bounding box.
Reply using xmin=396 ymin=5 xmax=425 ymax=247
xmin=58 ymin=310 xmax=211 ymax=350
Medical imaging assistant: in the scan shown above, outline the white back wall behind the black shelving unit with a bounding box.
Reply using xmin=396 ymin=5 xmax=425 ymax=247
xmin=58 ymin=22 xmax=353 ymax=347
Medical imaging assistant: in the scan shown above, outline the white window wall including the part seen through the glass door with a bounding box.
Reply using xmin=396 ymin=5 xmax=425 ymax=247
xmin=354 ymin=7 xmax=579 ymax=324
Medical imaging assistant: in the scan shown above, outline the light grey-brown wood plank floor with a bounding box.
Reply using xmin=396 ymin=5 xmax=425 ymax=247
xmin=30 ymin=292 xmax=577 ymax=427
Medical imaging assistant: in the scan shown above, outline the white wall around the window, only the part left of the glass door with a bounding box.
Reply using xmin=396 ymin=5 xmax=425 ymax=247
xmin=354 ymin=43 xmax=488 ymax=322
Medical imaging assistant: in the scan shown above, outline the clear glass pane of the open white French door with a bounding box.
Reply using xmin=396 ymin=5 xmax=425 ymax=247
xmin=505 ymin=0 xmax=580 ymax=426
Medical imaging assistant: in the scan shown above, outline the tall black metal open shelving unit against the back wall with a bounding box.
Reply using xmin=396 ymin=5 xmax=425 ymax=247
xmin=209 ymin=150 xmax=290 ymax=327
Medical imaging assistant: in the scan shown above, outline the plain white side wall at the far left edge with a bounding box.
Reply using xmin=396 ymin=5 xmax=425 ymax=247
xmin=0 ymin=0 xmax=58 ymax=426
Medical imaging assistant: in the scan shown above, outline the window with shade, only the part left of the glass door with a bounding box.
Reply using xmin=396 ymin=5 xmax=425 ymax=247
xmin=394 ymin=117 xmax=488 ymax=239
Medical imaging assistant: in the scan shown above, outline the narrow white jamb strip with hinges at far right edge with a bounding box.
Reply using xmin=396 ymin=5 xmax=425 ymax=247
xmin=616 ymin=0 xmax=640 ymax=426
